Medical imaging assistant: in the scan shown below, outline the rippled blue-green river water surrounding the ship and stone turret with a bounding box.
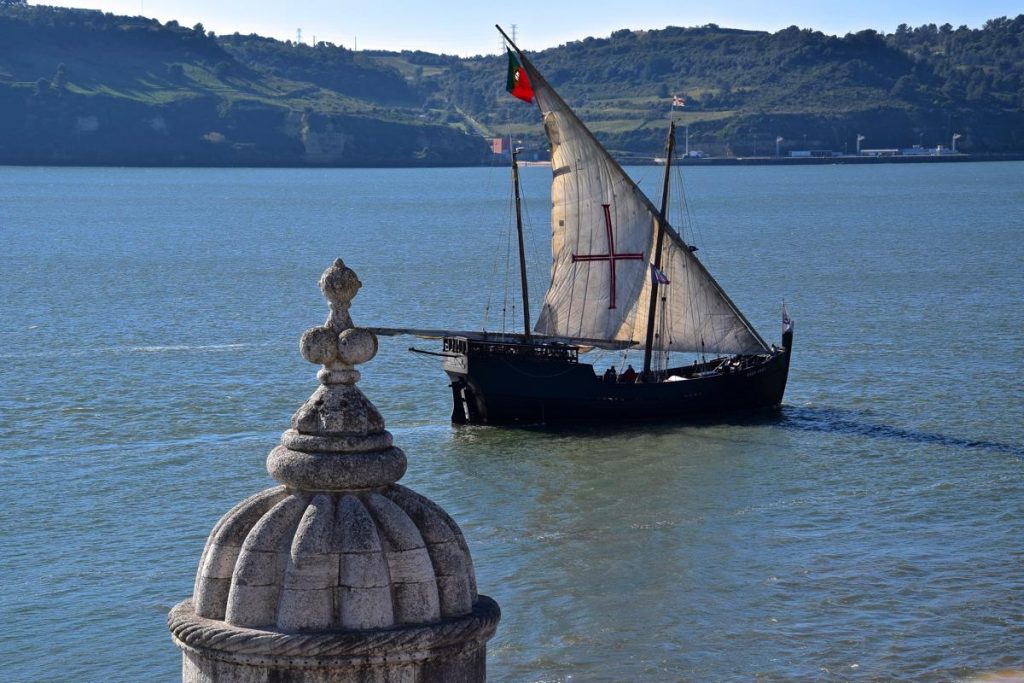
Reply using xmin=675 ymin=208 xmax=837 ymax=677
xmin=0 ymin=162 xmax=1024 ymax=682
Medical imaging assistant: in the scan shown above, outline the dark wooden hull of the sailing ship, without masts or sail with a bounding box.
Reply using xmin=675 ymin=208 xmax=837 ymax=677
xmin=444 ymin=332 xmax=793 ymax=425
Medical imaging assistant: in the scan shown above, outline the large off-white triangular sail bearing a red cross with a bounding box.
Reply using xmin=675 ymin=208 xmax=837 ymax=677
xmin=519 ymin=53 xmax=767 ymax=353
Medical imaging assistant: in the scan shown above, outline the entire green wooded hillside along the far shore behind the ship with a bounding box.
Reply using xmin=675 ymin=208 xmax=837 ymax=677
xmin=0 ymin=0 xmax=1024 ymax=166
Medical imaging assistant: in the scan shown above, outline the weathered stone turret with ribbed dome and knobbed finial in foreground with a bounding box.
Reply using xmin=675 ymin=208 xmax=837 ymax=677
xmin=168 ymin=259 xmax=500 ymax=683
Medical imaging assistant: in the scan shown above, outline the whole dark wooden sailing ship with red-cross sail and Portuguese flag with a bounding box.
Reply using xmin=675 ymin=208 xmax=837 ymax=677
xmin=375 ymin=27 xmax=793 ymax=425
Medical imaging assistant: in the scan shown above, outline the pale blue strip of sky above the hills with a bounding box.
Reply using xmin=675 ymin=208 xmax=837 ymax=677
xmin=36 ymin=0 xmax=1024 ymax=56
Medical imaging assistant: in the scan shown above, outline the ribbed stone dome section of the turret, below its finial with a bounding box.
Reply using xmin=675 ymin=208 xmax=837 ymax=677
xmin=194 ymin=484 xmax=477 ymax=632
